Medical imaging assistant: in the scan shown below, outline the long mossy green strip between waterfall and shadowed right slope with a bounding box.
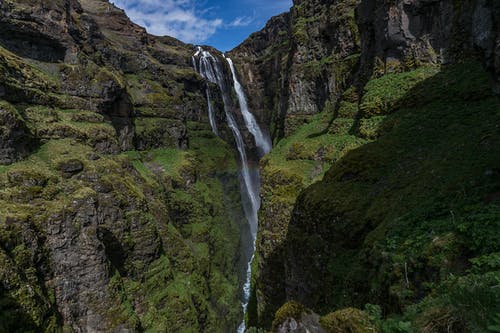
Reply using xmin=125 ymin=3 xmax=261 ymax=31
xmin=249 ymin=78 xmax=368 ymax=326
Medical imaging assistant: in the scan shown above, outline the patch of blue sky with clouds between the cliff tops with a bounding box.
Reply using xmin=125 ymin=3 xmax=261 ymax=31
xmin=111 ymin=0 xmax=292 ymax=51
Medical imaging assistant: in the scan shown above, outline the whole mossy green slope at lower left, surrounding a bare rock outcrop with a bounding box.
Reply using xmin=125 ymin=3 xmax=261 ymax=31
xmin=0 ymin=118 xmax=243 ymax=332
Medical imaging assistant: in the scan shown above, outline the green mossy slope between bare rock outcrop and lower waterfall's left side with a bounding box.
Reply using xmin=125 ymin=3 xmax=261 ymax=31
xmin=111 ymin=126 xmax=241 ymax=332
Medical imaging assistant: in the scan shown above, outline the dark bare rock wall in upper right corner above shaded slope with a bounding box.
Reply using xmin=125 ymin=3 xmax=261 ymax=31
xmin=358 ymin=0 xmax=500 ymax=89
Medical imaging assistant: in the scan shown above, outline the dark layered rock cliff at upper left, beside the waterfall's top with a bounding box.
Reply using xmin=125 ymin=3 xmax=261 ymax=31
xmin=0 ymin=1 xmax=209 ymax=152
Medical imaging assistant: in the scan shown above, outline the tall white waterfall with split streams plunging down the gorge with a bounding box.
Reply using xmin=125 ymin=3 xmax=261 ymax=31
xmin=193 ymin=47 xmax=271 ymax=333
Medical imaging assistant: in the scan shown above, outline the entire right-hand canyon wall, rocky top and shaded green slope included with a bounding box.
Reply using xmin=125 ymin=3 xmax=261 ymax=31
xmin=231 ymin=0 xmax=500 ymax=331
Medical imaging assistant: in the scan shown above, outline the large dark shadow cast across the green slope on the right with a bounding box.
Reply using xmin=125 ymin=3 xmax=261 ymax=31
xmin=256 ymin=61 xmax=500 ymax=327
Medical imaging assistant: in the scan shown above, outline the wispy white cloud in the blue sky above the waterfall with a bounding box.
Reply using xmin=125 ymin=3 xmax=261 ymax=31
xmin=115 ymin=0 xmax=225 ymax=43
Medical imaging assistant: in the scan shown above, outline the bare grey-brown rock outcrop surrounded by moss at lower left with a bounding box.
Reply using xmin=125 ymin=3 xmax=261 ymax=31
xmin=46 ymin=167 xmax=161 ymax=332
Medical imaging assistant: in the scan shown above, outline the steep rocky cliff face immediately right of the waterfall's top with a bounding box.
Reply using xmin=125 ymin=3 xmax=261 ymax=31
xmin=230 ymin=1 xmax=359 ymax=139
